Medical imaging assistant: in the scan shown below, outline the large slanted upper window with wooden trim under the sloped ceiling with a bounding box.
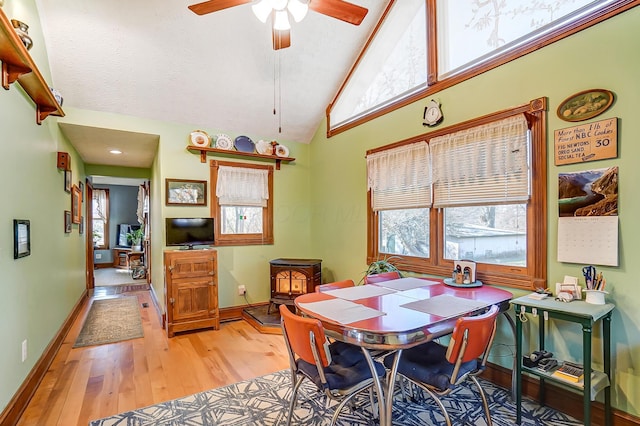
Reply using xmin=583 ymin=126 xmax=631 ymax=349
xmin=327 ymin=0 xmax=638 ymax=137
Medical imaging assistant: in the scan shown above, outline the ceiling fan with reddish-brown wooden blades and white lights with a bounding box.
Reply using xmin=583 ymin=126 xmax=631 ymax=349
xmin=189 ymin=0 xmax=368 ymax=50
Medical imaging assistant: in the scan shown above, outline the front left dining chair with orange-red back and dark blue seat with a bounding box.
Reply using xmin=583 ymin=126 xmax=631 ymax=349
xmin=280 ymin=305 xmax=385 ymax=425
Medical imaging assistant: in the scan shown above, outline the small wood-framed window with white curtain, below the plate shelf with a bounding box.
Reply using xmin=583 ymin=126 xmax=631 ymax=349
xmin=211 ymin=161 xmax=273 ymax=245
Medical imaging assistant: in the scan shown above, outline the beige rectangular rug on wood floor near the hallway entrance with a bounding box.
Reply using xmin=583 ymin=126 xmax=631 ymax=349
xmin=73 ymin=296 xmax=144 ymax=348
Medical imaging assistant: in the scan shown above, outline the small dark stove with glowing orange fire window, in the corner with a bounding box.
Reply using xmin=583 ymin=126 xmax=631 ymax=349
xmin=268 ymin=259 xmax=322 ymax=312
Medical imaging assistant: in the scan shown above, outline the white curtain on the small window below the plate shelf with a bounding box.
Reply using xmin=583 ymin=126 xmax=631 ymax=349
xmin=216 ymin=166 xmax=269 ymax=207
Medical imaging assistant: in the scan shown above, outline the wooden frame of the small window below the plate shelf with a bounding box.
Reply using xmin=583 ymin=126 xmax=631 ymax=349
xmin=209 ymin=160 xmax=273 ymax=246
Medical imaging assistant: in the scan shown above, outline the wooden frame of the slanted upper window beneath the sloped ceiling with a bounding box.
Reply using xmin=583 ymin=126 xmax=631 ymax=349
xmin=325 ymin=0 xmax=640 ymax=138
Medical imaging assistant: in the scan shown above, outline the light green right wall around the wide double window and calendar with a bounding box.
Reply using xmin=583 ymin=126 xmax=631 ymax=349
xmin=310 ymin=7 xmax=640 ymax=415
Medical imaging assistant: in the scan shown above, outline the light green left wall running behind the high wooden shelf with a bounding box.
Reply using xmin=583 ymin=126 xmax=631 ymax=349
xmin=0 ymin=1 xmax=85 ymax=408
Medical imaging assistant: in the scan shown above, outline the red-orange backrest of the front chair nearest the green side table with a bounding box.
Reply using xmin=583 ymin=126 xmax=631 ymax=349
xmin=447 ymin=305 xmax=500 ymax=365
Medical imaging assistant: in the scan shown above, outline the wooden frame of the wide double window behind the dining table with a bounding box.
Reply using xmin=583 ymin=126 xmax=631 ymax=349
xmin=367 ymin=98 xmax=547 ymax=289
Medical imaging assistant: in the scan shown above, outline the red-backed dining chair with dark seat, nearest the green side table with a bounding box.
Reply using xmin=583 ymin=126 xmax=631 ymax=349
xmin=384 ymin=305 xmax=499 ymax=426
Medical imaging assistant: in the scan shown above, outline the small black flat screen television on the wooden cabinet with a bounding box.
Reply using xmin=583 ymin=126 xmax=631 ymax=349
xmin=166 ymin=217 xmax=215 ymax=249
